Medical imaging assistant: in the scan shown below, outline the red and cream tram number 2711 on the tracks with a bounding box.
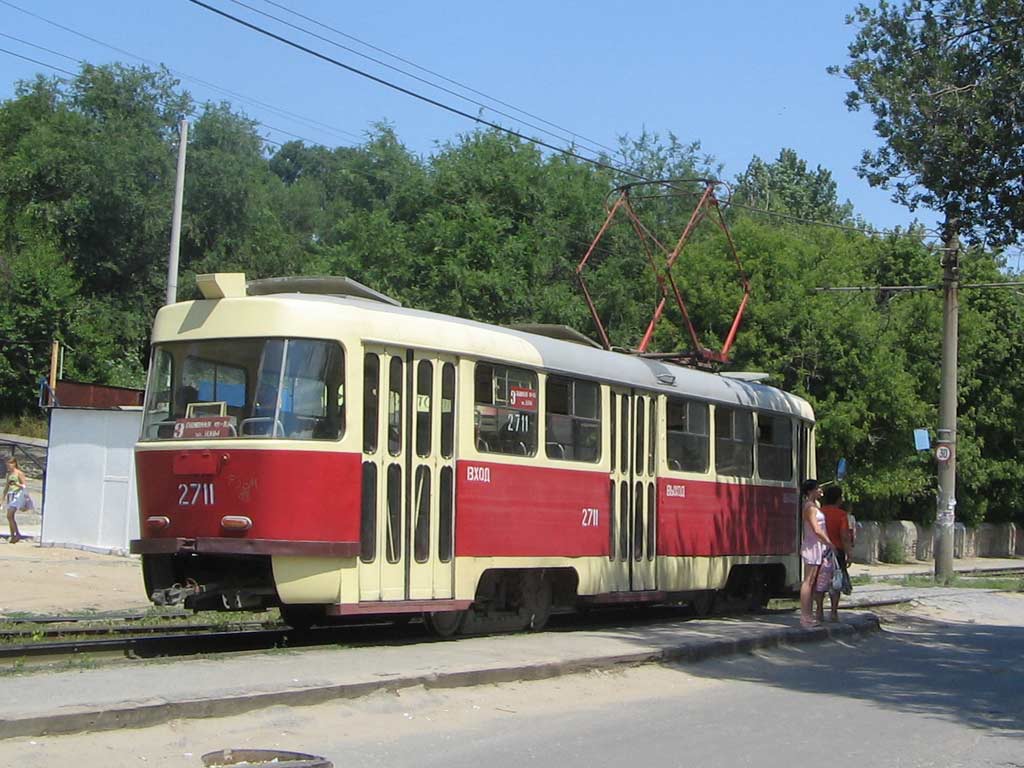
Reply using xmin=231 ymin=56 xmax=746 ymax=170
xmin=132 ymin=274 xmax=814 ymax=634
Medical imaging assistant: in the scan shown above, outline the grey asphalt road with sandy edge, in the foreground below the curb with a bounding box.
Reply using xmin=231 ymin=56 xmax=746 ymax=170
xmin=0 ymin=590 xmax=1024 ymax=768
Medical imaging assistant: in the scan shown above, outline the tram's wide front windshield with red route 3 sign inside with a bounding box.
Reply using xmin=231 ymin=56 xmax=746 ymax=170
xmin=142 ymin=339 xmax=345 ymax=440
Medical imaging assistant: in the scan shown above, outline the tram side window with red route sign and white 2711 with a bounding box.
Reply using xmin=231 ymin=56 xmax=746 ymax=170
xmin=473 ymin=362 xmax=538 ymax=456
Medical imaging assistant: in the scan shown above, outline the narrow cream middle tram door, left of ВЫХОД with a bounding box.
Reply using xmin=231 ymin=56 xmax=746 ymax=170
xmin=609 ymin=388 xmax=656 ymax=591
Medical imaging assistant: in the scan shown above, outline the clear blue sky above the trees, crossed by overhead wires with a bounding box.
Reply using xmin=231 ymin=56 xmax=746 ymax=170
xmin=0 ymin=0 xmax=935 ymax=234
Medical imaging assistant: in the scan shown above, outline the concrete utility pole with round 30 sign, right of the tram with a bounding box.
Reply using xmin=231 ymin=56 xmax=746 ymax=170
xmin=934 ymin=228 xmax=959 ymax=582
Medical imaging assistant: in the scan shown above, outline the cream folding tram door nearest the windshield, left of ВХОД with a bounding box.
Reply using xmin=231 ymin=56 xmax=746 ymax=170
xmin=358 ymin=347 xmax=455 ymax=601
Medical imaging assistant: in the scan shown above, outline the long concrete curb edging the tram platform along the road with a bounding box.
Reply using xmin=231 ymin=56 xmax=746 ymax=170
xmin=0 ymin=613 xmax=881 ymax=739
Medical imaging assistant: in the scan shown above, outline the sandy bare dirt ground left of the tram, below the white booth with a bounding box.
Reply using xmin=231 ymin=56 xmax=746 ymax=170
xmin=0 ymin=541 xmax=150 ymax=616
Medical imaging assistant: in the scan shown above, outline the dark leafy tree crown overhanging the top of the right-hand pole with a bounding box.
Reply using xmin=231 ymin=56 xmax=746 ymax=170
xmin=830 ymin=0 xmax=1024 ymax=244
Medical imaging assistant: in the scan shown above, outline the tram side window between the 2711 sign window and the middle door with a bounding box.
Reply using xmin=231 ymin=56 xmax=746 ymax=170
xmin=544 ymin=376 xmax=601 ymax=462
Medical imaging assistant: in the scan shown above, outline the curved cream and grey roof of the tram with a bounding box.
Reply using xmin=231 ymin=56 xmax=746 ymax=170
xmin=154 ymin=293 xmax=814 ymax=421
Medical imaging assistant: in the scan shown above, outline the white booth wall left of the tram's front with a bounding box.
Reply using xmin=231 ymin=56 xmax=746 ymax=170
xmin=41 ymin=408 xmax=142 ymax=552
